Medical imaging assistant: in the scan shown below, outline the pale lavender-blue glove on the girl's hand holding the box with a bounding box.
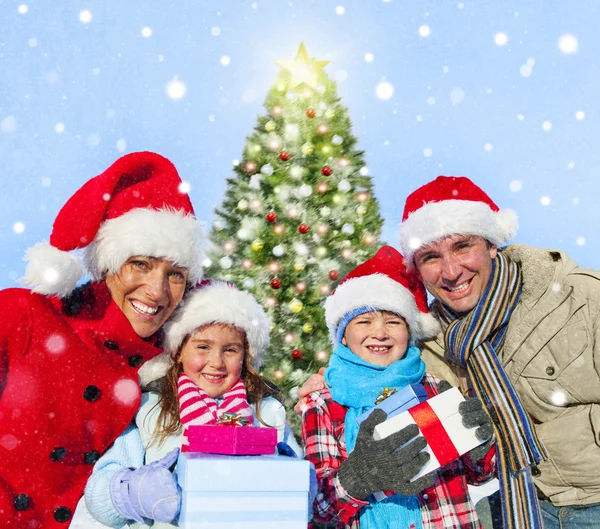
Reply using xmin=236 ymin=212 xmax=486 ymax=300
xmin=110 ymin=448 xmax=181 ymax=524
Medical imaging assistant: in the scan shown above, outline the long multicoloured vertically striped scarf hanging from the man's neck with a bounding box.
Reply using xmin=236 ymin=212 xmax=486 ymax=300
xmin=434 ymin=252 xmax=548 ymax=529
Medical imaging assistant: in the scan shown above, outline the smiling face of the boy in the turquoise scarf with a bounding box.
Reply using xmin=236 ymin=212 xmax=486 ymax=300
xmin=342 ymin=310 xmax=410 ymax=367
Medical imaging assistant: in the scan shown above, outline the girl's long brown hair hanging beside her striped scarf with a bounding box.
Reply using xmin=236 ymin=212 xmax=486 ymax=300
xmin=150 ymin=323 xmax=281 ymax=446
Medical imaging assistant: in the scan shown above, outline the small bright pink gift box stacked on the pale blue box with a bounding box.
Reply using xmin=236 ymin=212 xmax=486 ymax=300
xmin=181 ymin=425 xmax=277 ymax=456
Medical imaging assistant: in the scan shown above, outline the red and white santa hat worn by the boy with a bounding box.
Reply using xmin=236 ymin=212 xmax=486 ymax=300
xmin=325 ymin=246 xmax=440 ymax=344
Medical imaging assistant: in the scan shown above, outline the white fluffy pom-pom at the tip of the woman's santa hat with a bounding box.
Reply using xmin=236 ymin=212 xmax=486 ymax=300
xmin=20 ymin=242 xmax=83 ymax=297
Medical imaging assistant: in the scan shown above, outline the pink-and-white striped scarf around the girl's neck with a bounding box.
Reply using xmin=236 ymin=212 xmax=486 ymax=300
xmin=177 ymin=373 xmax=253 ymax=428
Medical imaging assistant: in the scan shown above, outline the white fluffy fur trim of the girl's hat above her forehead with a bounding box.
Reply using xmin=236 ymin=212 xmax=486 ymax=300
xmin=164 ymin=280 xmax=271 ymax=369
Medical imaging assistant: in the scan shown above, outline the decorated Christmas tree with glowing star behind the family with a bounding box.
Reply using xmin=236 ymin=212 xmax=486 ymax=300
xmin=208 ymin=44 xmax=383 ymax=424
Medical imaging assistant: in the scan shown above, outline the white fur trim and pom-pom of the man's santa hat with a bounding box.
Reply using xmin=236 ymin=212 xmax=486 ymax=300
xmin=400 ymin=200 xmax=518 ymax=267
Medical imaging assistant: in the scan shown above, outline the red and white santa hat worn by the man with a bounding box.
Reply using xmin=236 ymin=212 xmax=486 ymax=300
xmin=400 ymin=176 xmax=518 ymax=268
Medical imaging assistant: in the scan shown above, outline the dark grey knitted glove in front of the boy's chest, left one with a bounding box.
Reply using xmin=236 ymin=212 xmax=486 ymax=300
xmin=338 ymin=409 xmax=435 ymax=500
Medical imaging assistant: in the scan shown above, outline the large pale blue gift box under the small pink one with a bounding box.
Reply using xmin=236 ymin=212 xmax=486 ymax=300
xmin=177 ymin=452 xmax=312 ymax=529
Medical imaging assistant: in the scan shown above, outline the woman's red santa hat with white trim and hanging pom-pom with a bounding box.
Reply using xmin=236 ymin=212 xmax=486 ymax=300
xmin=23 ymin=152 xmax=204 ymax=296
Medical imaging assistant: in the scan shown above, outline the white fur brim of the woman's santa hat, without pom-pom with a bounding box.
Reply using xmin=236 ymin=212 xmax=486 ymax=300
xmin=83 ymin=208 xmax=204 ymax=284
